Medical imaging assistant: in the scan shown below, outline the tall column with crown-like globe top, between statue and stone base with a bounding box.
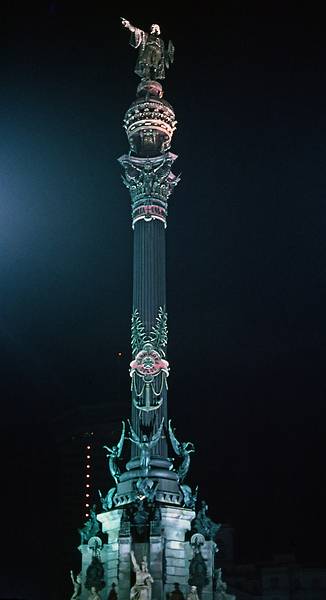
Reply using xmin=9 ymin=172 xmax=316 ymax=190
xmin=115 ymin=46 xmax=182 ymax=506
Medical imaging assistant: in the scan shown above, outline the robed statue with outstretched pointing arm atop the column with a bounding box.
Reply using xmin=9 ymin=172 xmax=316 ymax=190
xmin=121 ymin=17 xmax=174 ymax=81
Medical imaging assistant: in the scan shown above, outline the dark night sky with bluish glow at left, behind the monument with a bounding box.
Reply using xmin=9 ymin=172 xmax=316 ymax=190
xmin=0 ymin=1 xmax=326 ymax=598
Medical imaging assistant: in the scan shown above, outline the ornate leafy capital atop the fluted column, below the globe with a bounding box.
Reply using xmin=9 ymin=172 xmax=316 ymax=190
xmin=119 ymin=152 xmax=180 ymax=229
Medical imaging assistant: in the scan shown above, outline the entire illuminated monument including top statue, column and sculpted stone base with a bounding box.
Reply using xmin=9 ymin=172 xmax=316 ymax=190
xmin=72 ymin=19 xmax=231 ymax=600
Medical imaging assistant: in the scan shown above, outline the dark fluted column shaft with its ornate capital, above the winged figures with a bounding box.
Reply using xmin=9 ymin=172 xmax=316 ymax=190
xmin=119 ymin=152 xmax=179 ymax=458
